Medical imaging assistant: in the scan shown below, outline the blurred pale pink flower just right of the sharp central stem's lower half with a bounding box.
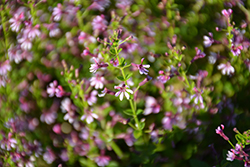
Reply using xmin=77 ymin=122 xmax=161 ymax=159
xmin=143 ymin=96 xmax=161 ymax=115
